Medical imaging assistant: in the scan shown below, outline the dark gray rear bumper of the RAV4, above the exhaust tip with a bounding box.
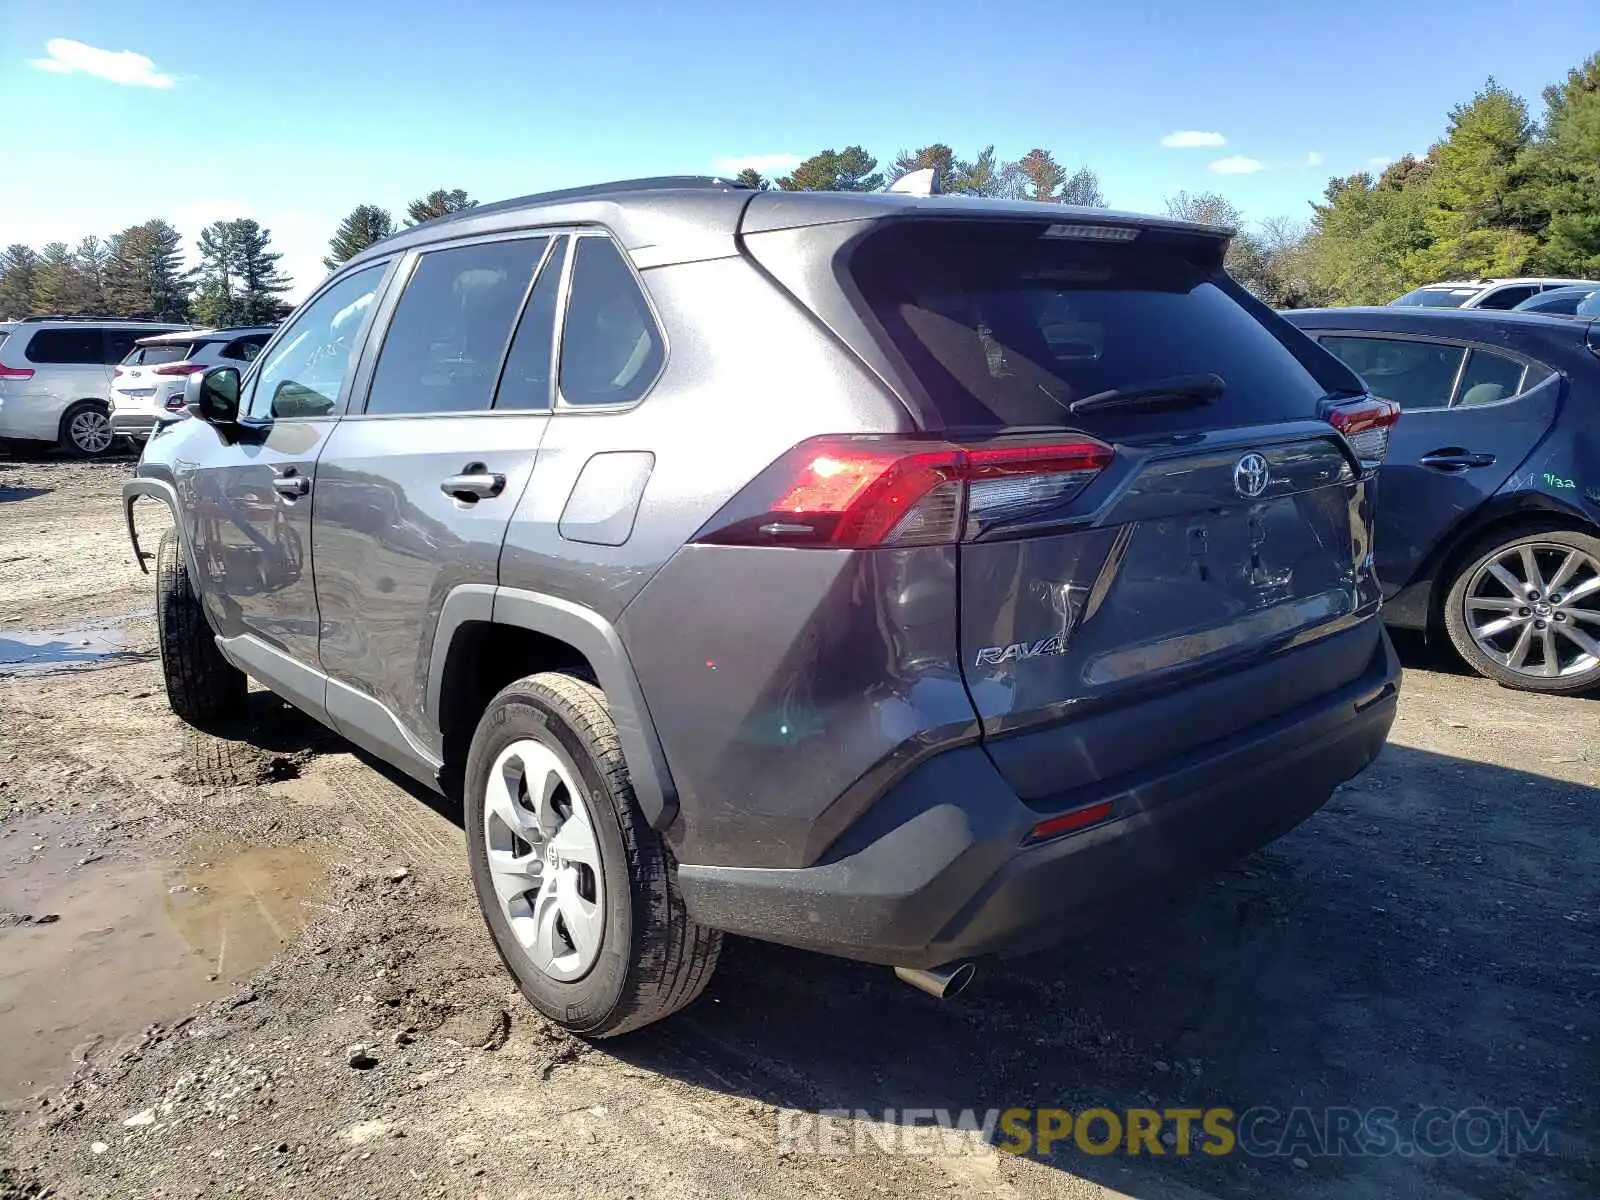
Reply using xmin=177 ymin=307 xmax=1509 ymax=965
xmin=678 ymin=637 xmax=1400 ymax=966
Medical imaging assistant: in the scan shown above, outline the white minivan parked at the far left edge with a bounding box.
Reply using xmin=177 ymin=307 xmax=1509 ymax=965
xmin=0 ymin=317 xmax=179 ymax=458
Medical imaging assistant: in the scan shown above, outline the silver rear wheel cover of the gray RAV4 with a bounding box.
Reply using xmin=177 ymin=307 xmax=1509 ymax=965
xmin=483 ymin=738 xmax=605 ymax=982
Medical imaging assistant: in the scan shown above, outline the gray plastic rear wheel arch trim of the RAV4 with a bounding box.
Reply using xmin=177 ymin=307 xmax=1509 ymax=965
xmin=427 ymin=584 xmax=678 ymax=830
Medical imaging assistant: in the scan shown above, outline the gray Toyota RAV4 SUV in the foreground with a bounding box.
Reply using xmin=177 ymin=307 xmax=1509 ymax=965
xmin=125 ymin=179 xmax=1400 ymax=1035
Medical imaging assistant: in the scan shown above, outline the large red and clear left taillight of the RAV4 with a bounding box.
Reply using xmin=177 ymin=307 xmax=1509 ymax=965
xmin=694 ymin=437 xmax=1112 ymax=549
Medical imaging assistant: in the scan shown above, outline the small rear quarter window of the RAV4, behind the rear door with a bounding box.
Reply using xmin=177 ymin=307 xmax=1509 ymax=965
xmin=562 ymin=237 xmax=666 ymax=405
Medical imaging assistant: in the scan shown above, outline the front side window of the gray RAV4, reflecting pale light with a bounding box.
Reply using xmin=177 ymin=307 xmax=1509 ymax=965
xmin=246 ymin=264 xmax=386 ymax=421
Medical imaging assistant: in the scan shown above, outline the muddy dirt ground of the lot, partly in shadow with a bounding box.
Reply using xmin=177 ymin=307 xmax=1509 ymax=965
xmin=0 ymin=453 xmax=1600 ymax=1200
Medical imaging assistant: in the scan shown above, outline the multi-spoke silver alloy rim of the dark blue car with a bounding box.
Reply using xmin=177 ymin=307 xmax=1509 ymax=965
xmin=1464 ymin=542 xmax=1600 ymax=678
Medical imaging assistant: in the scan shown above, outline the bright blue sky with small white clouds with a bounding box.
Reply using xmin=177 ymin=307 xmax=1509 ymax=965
xmin=9 ymin=0 xmax=1600 ymax=299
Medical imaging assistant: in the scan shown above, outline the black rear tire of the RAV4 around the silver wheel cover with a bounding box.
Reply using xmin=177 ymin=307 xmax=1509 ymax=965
xmin=464 ymin=672 xmax=722 ymax=1038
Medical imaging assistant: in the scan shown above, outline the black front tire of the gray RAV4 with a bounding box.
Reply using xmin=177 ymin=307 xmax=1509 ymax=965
xmin=155 ymin=530 xmax=250 ymax=730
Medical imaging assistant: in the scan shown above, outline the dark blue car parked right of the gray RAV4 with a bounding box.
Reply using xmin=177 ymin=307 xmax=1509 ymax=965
xmin=1285 ymin=307 xmax=1600 ymax=693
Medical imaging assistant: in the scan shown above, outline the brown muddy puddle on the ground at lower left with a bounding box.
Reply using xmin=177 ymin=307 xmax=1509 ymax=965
xmin=0 ymin=830 xmax=330 ymax=1102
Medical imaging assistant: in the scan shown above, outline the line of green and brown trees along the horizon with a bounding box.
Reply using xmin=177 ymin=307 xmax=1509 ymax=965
xmin=0 ymin=53 xmax=1600 ymax=325
